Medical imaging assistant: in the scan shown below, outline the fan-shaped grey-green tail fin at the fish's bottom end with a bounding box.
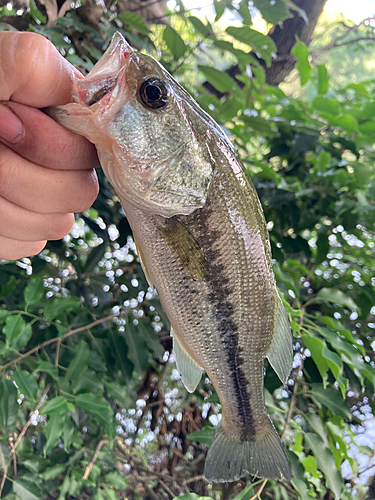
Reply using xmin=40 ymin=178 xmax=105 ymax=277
xmin=204 ymin=415 xmax=292 ymax=483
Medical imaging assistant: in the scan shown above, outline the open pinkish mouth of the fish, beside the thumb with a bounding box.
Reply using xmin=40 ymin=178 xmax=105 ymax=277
xmin=73 ymin=31 xmax=134 ymax=111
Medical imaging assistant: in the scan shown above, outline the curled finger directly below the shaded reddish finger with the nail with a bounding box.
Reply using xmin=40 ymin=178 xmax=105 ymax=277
xmin=0 ymin=143 xmax=99 ymax=214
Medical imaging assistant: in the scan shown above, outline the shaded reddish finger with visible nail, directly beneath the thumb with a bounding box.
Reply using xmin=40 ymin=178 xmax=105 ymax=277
xmin=0 ymin=102 xmax=100 ymax=170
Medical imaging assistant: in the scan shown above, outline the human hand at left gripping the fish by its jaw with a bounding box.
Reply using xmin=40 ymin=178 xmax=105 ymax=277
xmin=0 ymin=32 xmax=99 ymax=260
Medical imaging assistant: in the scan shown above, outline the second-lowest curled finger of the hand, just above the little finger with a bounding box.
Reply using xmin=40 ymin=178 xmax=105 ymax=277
xmin=0 ymin=197 xmax=74 ymax=241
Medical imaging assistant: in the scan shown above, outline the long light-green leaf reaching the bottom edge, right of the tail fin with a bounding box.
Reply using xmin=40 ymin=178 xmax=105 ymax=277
xmin=305 ymin=432 xmax=343 ymax=500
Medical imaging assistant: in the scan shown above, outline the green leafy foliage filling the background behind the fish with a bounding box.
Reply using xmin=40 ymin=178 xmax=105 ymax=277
xmin=0 ymin=0 xmax=375 ymax=500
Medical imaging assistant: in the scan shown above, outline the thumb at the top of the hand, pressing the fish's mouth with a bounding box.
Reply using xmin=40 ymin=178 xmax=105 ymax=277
xmin=0 ymin=32 xmax=82 ymax=108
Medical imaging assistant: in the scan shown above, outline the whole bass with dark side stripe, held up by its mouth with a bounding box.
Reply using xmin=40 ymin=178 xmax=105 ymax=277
xmin=49 ymin=33 xmax=293 ymax=483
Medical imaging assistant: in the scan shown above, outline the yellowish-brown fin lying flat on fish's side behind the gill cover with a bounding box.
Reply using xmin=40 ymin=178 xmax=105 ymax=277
xmin=158 ymin=217 xmax=209 ymax=280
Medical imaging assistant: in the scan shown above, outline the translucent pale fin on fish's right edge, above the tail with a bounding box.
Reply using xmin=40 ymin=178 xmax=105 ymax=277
xmin=267 ymin=294 xmax=293 ymax=384
